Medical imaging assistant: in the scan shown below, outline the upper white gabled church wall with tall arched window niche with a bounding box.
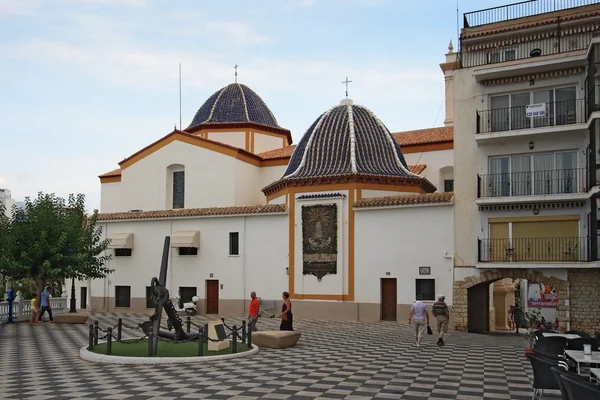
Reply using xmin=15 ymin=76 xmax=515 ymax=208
xmin=120 ymin=141 xmax=242 ymax=211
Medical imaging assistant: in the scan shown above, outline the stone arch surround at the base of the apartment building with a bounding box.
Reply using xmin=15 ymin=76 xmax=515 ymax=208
xmin=452 ymin=268 xmax=570 ymax=332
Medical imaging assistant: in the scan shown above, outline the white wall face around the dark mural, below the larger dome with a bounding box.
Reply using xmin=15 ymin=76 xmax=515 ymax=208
xmin=293 ymin=190 xmax=348 ymax=296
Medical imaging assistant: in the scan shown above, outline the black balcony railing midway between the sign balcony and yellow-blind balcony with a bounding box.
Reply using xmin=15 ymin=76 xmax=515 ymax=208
xmin=477 ymin=168 xmax=587 ymax=198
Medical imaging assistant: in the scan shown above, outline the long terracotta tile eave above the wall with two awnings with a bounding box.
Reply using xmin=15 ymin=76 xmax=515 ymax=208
xmin=98 ymin=204 xmax=287 ymax=221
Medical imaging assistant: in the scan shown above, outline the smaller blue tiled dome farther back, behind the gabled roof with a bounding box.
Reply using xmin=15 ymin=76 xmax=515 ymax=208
xmin=186 ymin=83 xmax=280 ymax=129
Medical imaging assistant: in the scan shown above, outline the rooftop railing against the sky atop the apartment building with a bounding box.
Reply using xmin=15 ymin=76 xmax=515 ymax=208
xmin=463 ymin=0 xmax=598 ymax=28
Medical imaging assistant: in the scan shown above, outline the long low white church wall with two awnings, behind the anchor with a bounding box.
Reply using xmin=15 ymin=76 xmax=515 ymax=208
xmin=83 ymin=214 xmax=288 ymax=315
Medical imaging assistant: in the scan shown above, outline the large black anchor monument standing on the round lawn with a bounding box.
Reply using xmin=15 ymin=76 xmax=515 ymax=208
xmin=139 ymin=236 xmax=199 ymax=354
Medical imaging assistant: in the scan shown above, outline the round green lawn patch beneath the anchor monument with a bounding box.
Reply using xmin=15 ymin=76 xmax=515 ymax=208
xmin=92 ymin=339 xmax=250 ymax=357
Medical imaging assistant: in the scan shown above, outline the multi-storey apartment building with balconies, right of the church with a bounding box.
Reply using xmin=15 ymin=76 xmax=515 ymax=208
xmin=452 ymin=0 xmax=600 ymax=332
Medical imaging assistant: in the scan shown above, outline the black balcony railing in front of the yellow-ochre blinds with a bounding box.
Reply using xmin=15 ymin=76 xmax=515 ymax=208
xmin=477 ymin=237 xmax=590 ymax=263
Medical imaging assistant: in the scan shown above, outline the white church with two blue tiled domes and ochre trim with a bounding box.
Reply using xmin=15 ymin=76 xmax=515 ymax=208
xmin=77 ymin=72 xmax=454 ymax=321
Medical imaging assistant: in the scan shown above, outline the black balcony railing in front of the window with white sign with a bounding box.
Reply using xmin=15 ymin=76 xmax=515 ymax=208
xmin=477 ymin=99 xmax=586 ymax=133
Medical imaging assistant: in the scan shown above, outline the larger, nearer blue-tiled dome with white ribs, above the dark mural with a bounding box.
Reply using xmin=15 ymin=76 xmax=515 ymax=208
xmin=263 ymin=99 xmax=435 ymax=193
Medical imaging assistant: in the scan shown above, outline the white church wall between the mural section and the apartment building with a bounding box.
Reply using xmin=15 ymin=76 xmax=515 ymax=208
xmin=354 ymin=205 xmax=454 ymax=305
